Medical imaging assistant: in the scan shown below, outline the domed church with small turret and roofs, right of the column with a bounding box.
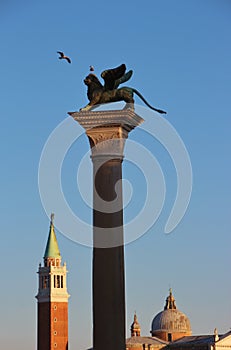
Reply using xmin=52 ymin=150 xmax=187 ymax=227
xmin=126 ymin=289 xmax=231 ymax=350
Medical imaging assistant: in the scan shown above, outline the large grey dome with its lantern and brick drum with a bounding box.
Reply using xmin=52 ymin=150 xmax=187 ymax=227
xmin=151 ymin=289 xmax=191 ymax=341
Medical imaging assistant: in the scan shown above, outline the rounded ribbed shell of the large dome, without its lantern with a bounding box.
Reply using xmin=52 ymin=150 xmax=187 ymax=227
xmin=152 ymin=309 xmax=191 ymax=333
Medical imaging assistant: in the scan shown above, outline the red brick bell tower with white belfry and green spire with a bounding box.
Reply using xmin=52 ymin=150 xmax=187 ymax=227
xmin=36 ymin=214 xmax=69 ymax=350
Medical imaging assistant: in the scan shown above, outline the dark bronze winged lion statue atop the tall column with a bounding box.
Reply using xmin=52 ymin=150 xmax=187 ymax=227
xmin=80 ymin=64 xmax=166 ymax=114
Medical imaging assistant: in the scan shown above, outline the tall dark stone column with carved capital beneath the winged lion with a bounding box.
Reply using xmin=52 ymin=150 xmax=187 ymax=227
xmin=70 ymin=109 xmax=143 ymax=350
